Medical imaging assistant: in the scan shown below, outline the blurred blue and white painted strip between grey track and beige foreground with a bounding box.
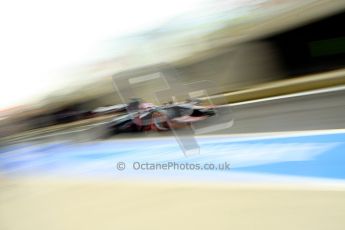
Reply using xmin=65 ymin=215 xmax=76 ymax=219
xmin=0 ymin=133 xmax=345 ymax=179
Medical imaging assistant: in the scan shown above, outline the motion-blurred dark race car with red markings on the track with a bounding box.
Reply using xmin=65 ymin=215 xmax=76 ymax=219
xmin=102 ymin=100 xmax=215 ymax=135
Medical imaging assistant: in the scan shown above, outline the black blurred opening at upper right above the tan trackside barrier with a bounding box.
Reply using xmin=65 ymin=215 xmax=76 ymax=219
xmin=265 ymin=12 xmax=345 ymax=77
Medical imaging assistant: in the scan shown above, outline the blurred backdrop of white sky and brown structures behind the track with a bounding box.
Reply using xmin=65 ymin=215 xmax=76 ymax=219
xmin=0 ymin=0 xmax=345 ymax=137
